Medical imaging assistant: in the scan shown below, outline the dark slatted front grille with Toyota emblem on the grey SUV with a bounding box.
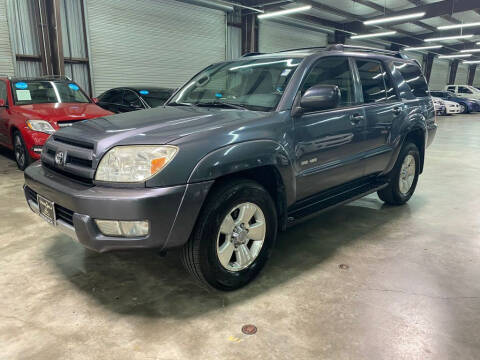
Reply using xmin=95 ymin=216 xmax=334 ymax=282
xmin=42 ymin=135 xmax=95 ymax=184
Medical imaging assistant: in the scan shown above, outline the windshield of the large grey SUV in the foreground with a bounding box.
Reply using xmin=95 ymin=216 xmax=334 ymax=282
xmin=168 ymin=58 xmax=302 ymax=111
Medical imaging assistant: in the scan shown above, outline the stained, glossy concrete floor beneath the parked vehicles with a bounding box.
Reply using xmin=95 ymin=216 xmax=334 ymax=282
xmin=0 ymin=115 xmax=480 ymax=360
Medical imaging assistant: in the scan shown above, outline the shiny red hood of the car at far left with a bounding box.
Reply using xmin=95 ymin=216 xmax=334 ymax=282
xmin=15 ymin=103 xmax=112 ymax=122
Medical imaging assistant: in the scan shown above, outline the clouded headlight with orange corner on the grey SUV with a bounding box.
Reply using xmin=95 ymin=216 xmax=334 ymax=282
xmin=95 ymin=145 xmax=178 ymax=182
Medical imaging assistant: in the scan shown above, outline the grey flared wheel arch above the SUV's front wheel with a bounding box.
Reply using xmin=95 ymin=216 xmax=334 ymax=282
xmin=188 ymin=140 xmax=295 ymax=204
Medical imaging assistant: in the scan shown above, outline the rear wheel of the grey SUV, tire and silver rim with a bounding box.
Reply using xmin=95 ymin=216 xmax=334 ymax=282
xmin=377 ymin=142 xmax=420 ymax=205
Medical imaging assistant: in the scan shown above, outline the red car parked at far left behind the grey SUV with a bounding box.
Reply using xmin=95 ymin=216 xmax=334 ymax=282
xmin=0 ymin=77 xmax=113 ymax=170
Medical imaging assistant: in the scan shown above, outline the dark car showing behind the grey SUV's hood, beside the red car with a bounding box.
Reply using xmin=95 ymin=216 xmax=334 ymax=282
xmin=97 ymin=86 xmax=174 ymax=113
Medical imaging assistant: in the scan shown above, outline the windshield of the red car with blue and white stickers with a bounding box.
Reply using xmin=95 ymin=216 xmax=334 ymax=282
xmin=12 ymin=80 xmax=90 ymax=105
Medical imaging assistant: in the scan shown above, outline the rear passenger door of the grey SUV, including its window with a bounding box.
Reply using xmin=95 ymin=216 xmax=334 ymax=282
xmin=355 ymin=58 xmax=405 ymax=175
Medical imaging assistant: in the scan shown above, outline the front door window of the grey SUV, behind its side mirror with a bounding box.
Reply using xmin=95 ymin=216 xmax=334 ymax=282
xmin=301 ymin=56 xmax=355 ymax=106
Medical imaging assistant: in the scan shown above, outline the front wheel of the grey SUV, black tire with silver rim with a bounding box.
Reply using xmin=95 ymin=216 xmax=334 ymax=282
xmin=182 ymin=180 xmax=277 ymax=291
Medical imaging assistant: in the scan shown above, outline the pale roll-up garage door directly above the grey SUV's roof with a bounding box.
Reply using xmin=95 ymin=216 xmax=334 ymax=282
xmin=258 ymin=21 xmax=327 ymax=52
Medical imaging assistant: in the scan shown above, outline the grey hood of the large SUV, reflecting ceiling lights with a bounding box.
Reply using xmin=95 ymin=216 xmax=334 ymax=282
xmin=55 ymin=106 xmax=270 ymax=153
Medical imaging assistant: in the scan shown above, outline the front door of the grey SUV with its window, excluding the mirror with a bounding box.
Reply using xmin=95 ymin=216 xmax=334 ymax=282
xmin=294 ymin=56 xmax=365 ymax=200
